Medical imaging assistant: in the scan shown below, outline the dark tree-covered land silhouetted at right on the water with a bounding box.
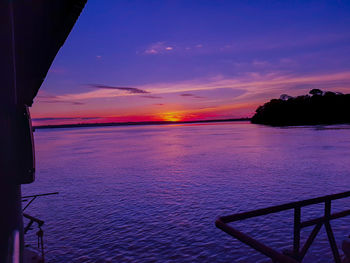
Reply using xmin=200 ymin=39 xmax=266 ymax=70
xmin=251 ymin=89 xmax=350 ymax=126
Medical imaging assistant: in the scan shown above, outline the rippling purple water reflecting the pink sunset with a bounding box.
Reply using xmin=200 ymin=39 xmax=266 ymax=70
xmin=22 ymin=122 xmax=350 ymax=263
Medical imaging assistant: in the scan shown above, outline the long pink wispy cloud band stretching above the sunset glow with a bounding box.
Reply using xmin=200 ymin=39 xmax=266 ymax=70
xmin=39 ymin=71 xmax=350 ymax=108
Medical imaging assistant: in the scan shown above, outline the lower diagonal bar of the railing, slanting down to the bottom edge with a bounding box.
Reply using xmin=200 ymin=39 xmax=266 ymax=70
xmin=215 ymin=218 xmax=297 ymax=263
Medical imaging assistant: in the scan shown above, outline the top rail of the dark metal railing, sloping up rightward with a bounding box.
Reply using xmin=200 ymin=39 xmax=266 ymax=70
xmin=220 ymin=191 xmax=350 ymax=223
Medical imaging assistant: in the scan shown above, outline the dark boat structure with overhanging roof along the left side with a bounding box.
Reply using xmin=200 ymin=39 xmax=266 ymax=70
xmin=0 ymin=0 xmax=86 ymax=263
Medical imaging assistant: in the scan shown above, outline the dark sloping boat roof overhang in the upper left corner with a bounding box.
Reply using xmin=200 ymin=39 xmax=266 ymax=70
xmin=0 ymin=0 xmax=86 ymax=106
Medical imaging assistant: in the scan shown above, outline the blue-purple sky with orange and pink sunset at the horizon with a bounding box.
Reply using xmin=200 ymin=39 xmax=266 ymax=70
xmin=31 ymin=0 xmax=350 ymax=125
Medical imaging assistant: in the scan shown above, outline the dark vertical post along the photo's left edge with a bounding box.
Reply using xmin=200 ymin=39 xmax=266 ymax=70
xmin=0 ymin=1 xmax=23 ymax=262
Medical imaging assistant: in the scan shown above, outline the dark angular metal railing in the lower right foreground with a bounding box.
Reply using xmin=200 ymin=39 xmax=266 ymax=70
xmin=215 ymin=191 xmax=350 ymax=263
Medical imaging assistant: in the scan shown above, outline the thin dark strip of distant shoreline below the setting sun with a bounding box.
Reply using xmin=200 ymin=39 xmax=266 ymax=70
xmin=33 ymin=118 xmax=251 ymax=130
